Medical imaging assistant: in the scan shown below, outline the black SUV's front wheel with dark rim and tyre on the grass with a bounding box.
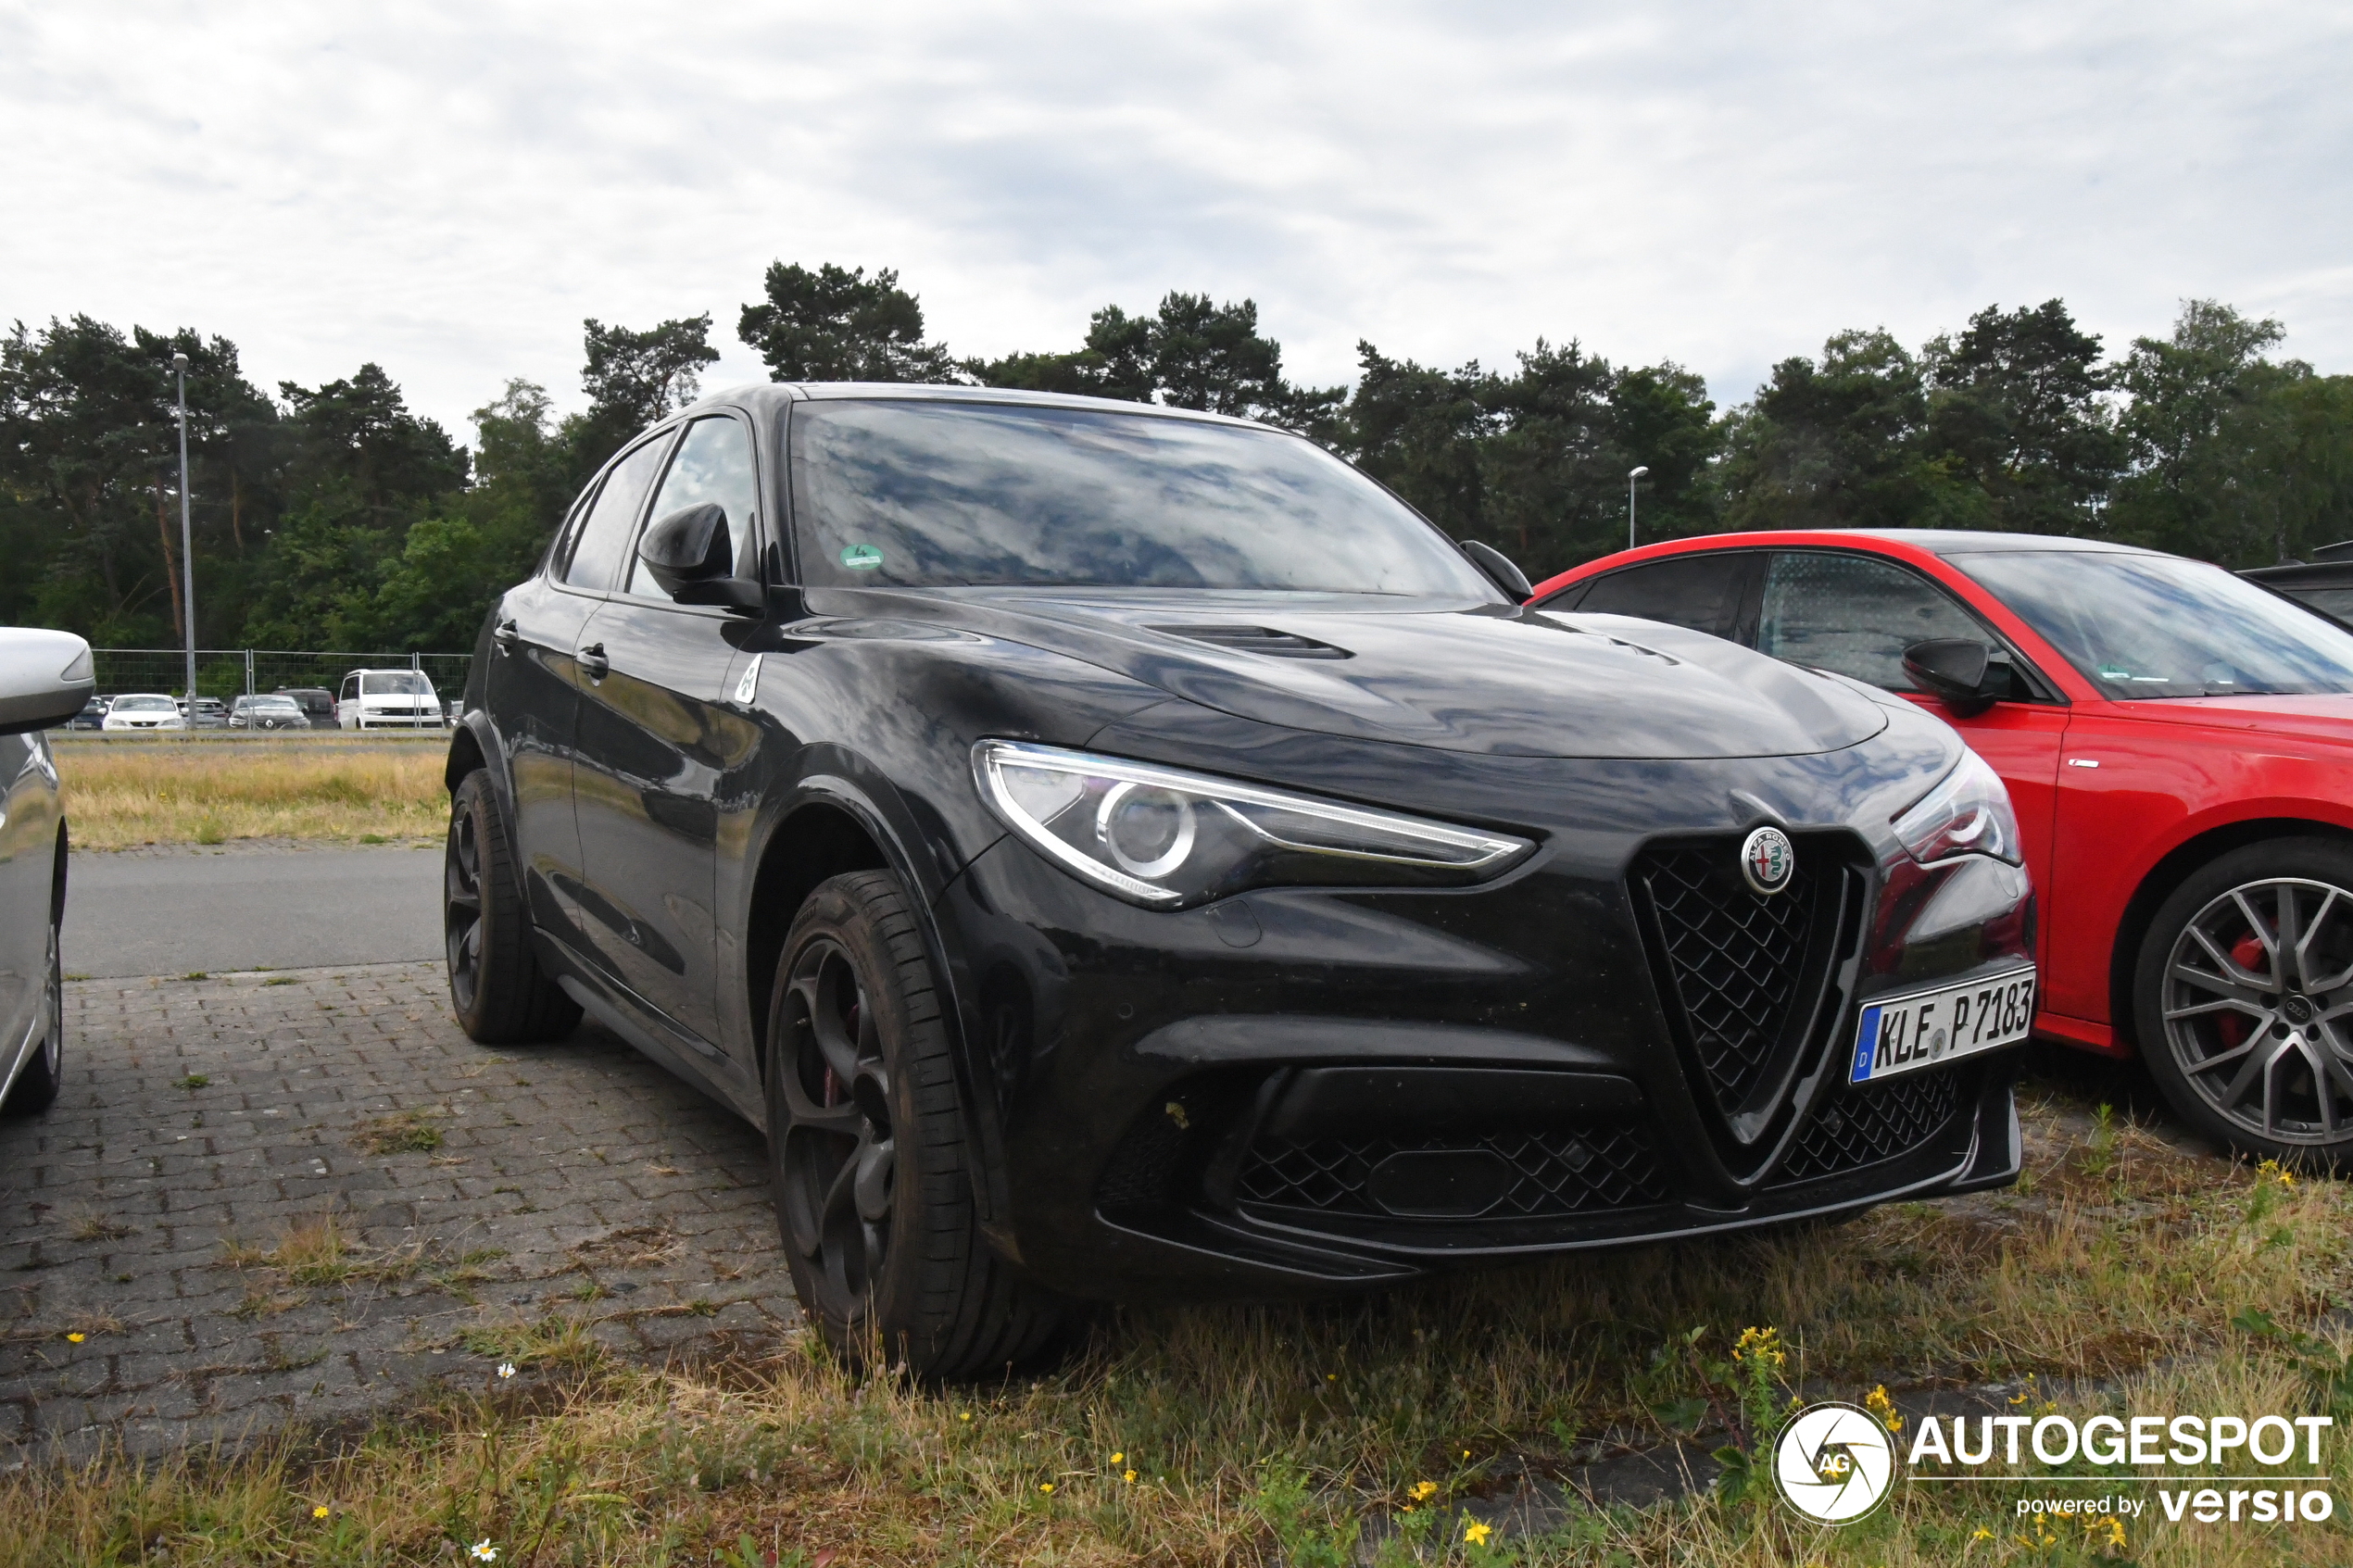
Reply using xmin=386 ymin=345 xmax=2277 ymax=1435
xmin=767 ymin=872 xmax=1068 ymax=1380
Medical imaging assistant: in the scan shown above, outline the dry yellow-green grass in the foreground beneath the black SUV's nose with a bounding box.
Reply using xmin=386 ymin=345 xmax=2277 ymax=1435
xmin=13 ymin=1096 xmax=2353 ymax=1568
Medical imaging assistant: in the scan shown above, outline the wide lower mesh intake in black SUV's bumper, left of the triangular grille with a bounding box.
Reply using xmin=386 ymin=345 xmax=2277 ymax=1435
xmin=1236 ymin=1126 xmax=1668 ymax=1220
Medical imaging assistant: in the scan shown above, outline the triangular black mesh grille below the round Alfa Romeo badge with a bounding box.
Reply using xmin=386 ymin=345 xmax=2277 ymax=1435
xmin=1633 ymin=839 xmax=1840 ymax=1117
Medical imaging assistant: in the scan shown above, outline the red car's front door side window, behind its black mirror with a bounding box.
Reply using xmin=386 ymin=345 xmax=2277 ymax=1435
xmin=1757 ymin=550 xmax=1995 ymax=691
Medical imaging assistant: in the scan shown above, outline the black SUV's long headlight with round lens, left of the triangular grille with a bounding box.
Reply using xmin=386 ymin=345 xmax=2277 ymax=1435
xmin=972 ymin=741 xmax=1534 ymax=909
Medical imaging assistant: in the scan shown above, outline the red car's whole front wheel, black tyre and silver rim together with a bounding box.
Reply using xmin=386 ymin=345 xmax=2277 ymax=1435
xmin=2132 ymin=839 xmax=2353 ymax=1171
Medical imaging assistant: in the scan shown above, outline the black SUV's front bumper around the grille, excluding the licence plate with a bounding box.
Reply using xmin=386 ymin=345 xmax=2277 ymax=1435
xmin=937 ymin=780 xmax=2033 ymax=1298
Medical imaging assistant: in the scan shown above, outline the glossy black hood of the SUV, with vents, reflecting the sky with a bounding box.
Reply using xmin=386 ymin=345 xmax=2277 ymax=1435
xmin=812 ymin=588 xmax=1887 ymax=759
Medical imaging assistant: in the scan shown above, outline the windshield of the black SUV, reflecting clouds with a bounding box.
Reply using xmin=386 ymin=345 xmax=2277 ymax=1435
xmin=793 ymin=399 xmax=1496 ymax=599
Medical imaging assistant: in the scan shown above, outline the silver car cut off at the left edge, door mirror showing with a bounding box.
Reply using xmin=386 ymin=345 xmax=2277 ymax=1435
xmin=0 ymin=628 xmax=90 ymax=1114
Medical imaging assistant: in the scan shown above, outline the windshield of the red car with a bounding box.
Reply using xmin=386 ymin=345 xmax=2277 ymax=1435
xmin=1951 ymin=550 xmax=2353 ymax=698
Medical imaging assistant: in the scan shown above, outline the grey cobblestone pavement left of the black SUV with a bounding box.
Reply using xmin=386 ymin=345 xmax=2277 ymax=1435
xmin=0 ymin=964 xmax=798 ymax=1464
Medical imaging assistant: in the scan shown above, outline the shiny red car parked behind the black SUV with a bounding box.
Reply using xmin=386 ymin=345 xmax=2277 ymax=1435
xmin=1529 ymin=529 xmax=2353 ymax=1166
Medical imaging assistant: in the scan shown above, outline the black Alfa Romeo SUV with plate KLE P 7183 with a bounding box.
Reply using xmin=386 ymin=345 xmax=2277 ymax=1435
xmin=447 ymin=385 xmax=2033 ymax=1375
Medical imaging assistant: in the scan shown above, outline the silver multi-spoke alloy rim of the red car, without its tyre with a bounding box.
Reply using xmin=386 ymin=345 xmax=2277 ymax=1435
xmin=2162 ymin=877 xmax=2353 ymax=1145
